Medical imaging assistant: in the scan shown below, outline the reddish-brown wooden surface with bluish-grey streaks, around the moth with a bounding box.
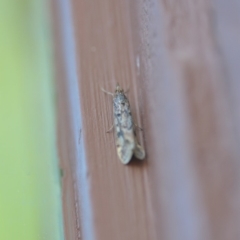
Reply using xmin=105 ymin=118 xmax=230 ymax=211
xmin=55 ymin=0 xmax=240 ymax=240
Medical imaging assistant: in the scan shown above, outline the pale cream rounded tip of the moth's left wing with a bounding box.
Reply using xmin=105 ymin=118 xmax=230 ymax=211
xmin=117 ymin=139 xmax=134 ymax=164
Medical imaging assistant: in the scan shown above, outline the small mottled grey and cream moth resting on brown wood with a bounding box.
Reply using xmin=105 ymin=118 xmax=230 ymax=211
xmin=102 ymin=84 xmax=145 ymax=164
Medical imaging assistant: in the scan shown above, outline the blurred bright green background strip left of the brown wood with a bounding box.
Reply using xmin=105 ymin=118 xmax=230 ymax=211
xmin=0 ymin=0 xmax=64 ymax=240
